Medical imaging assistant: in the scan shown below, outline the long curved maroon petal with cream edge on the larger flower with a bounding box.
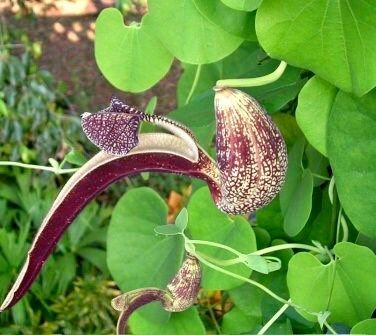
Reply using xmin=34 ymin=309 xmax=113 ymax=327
xmin=0 ymin=142 xmax=219 ymax=311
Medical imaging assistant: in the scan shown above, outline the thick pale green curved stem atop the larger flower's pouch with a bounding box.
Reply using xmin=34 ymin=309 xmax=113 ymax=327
xmin=216 ymin=61 xmax=287 ymax=87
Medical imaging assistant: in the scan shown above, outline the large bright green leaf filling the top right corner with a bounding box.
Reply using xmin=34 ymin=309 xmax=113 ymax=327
xmin=256 ymin=0 xmax=376 ymax=95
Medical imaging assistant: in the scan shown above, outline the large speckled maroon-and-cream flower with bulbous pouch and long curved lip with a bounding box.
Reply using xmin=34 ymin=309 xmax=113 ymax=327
xmin=0 ymin=88 xmax=287 ymax=311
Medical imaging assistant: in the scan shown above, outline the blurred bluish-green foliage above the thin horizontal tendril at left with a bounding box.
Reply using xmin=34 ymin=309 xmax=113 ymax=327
xmin=0 ymin=22 xmax=82 ymax=164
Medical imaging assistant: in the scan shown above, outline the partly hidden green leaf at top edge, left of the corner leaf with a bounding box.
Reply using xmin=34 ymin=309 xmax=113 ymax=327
xmin=193 ymin=0 xmax=257 ymax=41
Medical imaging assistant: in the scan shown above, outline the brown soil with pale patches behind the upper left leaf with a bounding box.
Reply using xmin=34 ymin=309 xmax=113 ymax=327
xmin=0 ymin=0 xmax=180 ymax=114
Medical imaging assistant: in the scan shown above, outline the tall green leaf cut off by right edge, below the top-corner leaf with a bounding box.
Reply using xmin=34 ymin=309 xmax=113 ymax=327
xmin=328 ymin=91 xmax=376 ymax=236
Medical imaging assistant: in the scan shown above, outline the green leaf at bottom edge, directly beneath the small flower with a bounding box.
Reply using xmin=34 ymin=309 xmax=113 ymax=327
xmin=129 ymin=307 xmax=206 ymax=335
